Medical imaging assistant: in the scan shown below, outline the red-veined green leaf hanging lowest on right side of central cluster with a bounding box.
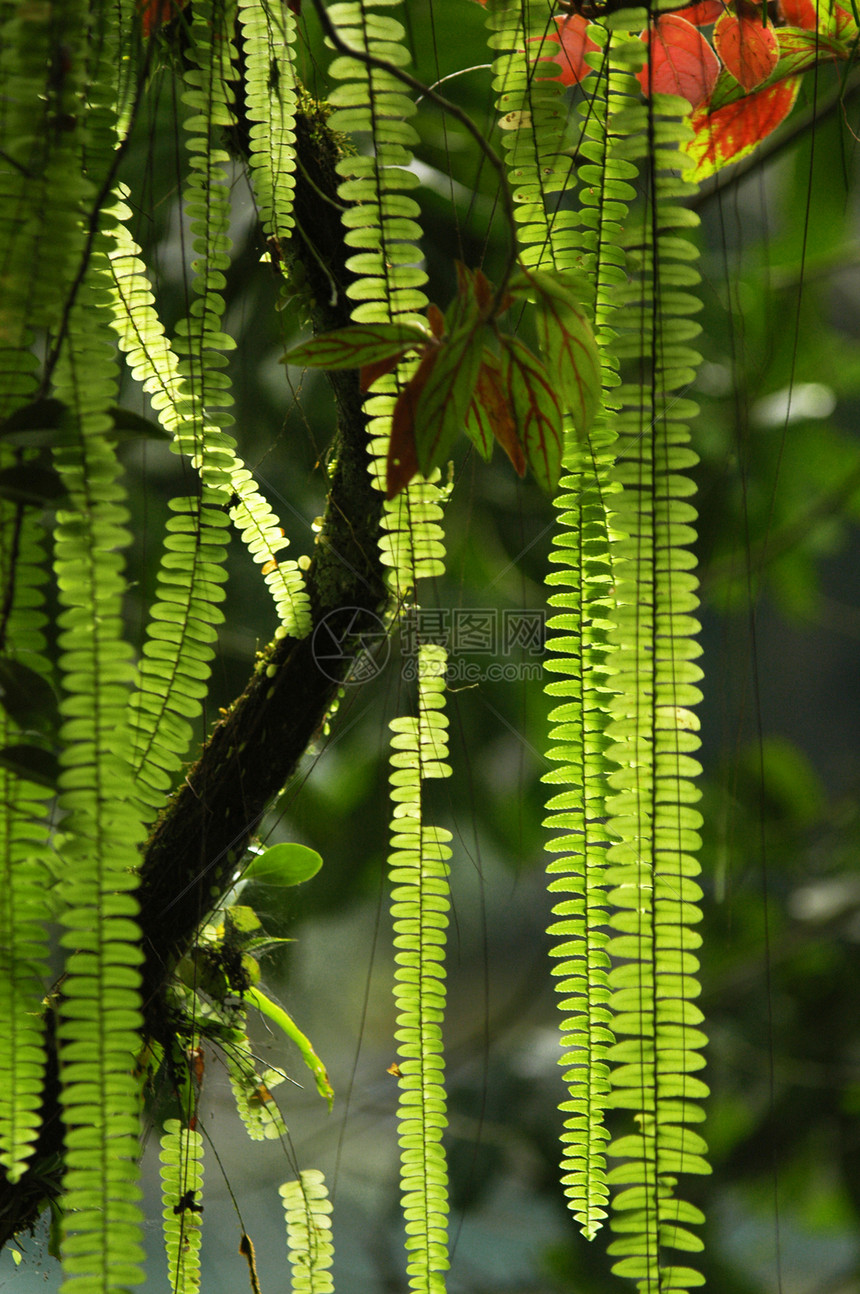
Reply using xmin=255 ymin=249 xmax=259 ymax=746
xmin=500 ymin=336 xmax=564 ymax=494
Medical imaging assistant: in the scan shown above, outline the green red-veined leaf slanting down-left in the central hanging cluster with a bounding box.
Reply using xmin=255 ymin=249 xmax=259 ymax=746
xmin=415 ymin=315 xmax=485 ymax=476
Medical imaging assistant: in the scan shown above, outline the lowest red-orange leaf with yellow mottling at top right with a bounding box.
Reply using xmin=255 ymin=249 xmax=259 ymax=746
xmin=685 ymin=76 xmax=801 ymax=180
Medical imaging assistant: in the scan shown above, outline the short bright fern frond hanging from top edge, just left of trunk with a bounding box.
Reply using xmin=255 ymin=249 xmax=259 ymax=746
xmin=239 ymin=0 xmax=297 ymax=238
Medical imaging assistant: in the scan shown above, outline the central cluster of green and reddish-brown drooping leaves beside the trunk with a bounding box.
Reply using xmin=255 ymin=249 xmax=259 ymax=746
xmin=285 ymin=264 xmax=600 ymax=498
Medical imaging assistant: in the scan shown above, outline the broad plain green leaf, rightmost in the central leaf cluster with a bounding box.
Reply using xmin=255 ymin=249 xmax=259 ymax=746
xmin=511 ymin=268 xmax=600 ymax=436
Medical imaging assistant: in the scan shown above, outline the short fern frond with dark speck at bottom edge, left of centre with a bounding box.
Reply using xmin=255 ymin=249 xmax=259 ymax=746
xmin=160 ymin=1119 xmax=203 ymax=1294
